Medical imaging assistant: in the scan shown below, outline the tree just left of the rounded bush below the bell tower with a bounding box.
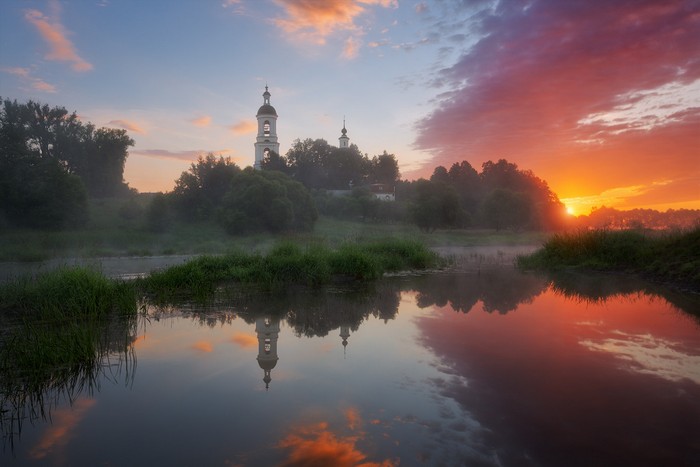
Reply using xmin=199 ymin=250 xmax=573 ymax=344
xmin=171 ymin=153 xmax=241 ymax=221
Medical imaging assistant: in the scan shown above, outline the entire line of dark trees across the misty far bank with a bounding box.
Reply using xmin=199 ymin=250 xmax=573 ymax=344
xmin=0 ymin=100 xmax=566 ymax=234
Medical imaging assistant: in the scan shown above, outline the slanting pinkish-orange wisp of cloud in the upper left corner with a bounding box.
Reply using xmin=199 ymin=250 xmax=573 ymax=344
xmin=24 ymin=3 xmax=93 ymax=72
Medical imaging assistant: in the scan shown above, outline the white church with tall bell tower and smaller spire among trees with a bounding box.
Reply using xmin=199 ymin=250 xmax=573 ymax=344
xmin=253 ymin=85 xmax=395 ymax=201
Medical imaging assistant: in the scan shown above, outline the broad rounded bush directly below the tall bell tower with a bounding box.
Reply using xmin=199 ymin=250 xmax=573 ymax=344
xmin=218 ymin=167 xmax=318 ymax=234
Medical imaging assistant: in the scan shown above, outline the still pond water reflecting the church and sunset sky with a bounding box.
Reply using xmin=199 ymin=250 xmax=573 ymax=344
xmin=0 ymin=268 xmax=700 ymax=466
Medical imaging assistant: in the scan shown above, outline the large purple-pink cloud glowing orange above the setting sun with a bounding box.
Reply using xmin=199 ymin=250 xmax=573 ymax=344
xmin=412 ymin=0 xmax=700 ymax=210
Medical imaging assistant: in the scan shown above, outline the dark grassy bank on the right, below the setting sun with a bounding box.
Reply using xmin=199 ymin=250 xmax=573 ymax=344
xmin=517 ymin=228 xmax=700 ymax=291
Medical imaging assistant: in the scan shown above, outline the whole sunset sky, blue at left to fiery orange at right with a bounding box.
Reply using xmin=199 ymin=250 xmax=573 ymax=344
xmin=0 ymin=0 xmax=700 ymax=214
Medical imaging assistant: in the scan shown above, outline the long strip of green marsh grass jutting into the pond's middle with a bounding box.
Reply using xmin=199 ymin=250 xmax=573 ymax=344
xmin=137 ymin=239 xmax=441 ymax=299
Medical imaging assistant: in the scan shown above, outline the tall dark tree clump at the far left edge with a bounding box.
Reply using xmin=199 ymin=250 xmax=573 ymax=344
xmin=0 ymin=99 xmax=134 ymax=229
